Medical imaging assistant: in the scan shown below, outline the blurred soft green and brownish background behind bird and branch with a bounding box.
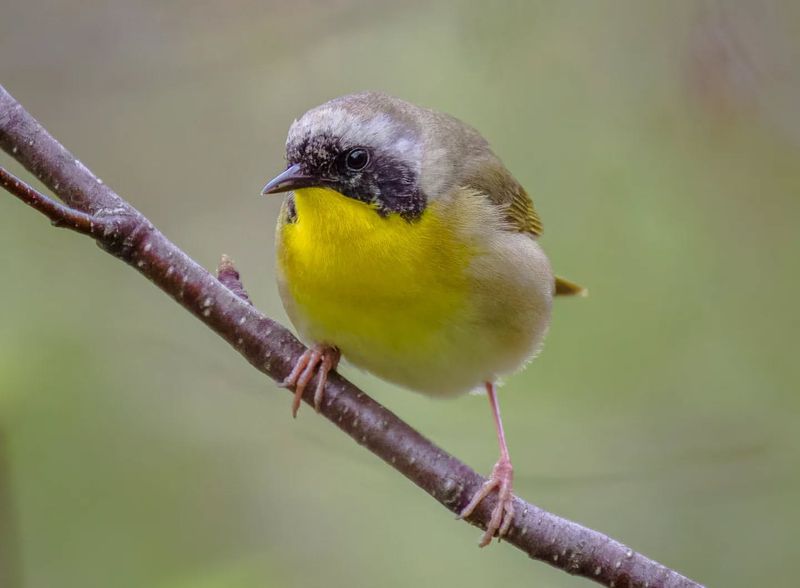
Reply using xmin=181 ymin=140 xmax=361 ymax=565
xmin=0 ymin=0 xmax=800 ymax=588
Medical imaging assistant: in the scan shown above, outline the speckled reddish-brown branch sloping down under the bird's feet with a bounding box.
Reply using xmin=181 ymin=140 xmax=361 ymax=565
xmin=0 ymin=86 xmax=700 ymax=588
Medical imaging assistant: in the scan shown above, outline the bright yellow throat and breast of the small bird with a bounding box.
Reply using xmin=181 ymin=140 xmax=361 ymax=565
xmin=278 ymin=188 xmax=473 ymax=362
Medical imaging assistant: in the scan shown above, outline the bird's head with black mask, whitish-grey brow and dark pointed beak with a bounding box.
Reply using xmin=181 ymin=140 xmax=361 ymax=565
xmin=262 ymin=92 xmax=488 ymax=221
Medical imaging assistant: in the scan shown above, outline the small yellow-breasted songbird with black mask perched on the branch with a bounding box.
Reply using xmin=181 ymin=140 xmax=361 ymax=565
xmin=262 ymin=92 xmax=584 ymax=546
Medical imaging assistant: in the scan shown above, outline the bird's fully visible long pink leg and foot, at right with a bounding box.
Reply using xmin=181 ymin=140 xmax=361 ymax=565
xmin=458 ymin=382 xmax=514 ymax=547
